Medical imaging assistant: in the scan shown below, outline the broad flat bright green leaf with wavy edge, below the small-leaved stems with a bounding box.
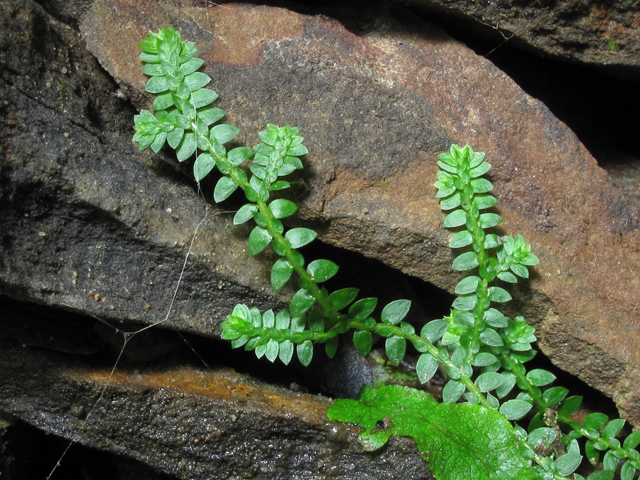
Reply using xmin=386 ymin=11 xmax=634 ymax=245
xmin=327 ymin=385 xmax=530 ymax=480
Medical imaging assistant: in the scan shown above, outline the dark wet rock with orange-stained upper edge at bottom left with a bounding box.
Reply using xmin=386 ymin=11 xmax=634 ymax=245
xmin=0 ymin=334 xmax=433 ymax=480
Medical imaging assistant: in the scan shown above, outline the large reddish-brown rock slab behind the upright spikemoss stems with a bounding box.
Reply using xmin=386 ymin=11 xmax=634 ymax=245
xmin=76 ymin=0 xmax=640 ymax=424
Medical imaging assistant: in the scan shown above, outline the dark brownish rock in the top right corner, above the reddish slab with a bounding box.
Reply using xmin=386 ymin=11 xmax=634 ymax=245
xmin=408 ymin=0 xmax=640 ymax=75
